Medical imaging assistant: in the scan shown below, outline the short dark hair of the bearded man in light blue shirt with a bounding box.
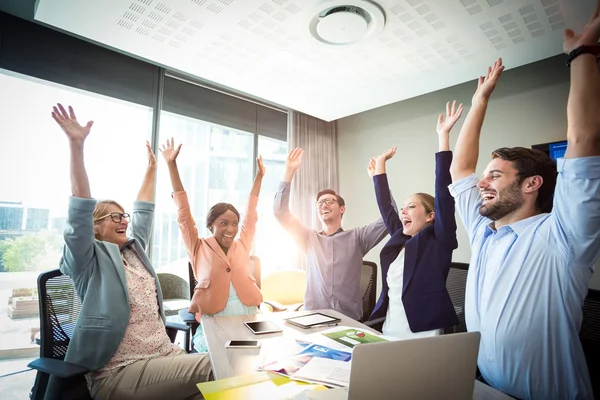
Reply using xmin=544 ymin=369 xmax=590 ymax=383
xmin=492 ymin=147 xmax=558 ymax=212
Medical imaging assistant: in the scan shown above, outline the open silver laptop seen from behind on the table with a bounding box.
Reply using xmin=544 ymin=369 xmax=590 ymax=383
xmin=348 ymin=332 xmax=481 ymax=400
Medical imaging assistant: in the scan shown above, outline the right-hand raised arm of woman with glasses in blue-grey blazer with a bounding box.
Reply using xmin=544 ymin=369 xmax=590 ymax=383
xmin=131 ymin=141 xmax=156 ymax=250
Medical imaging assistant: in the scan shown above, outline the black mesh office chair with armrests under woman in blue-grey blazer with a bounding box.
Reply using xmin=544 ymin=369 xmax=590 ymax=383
xmin=28 ymin=269 xmax=188 ymax=400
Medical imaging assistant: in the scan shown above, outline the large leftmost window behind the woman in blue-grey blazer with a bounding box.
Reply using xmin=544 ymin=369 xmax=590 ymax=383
xmin=0 ymin=70 xmax=152 ymax=358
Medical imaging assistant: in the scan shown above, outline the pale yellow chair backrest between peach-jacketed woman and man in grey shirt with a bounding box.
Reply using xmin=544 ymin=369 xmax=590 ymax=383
xmin=262 ymin=269 xmax=306 ymax=305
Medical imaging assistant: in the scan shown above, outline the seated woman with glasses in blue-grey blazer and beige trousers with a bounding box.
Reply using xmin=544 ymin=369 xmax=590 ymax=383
xmin=52 ymin=104 xmax=211 ymax=399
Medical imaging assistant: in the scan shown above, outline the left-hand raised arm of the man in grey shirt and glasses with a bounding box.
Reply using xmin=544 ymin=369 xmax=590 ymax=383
xmin=273 ymin=148 xmax=308 ymax=250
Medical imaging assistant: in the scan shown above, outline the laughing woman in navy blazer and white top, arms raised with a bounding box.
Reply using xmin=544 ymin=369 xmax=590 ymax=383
xmin=368 ymin=101 xmax=462 ymax=339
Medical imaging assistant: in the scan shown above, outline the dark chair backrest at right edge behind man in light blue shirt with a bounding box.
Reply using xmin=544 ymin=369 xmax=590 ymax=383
xmin=579 ymin=289 xmax=600 ymax=398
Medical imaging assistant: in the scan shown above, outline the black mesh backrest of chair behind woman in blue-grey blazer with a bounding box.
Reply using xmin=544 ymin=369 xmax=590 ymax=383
xmin=38 ymin=269 xmax=81 ymax=360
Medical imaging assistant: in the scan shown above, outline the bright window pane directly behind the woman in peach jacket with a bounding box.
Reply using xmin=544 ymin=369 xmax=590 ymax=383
xmin=152 ymin=111 xmax=254 ymax=278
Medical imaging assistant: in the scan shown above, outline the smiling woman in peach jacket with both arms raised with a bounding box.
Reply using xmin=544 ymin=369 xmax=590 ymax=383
xmin=160 ymin=139 xmax=265 ymax=352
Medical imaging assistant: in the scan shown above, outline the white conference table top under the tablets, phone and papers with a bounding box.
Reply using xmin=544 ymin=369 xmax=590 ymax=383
xmin=202 ymin=310 xmax=511 ymax=400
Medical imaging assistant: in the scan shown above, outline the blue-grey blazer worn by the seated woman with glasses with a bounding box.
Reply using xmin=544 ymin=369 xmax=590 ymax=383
xmin=60 ymin=197 xmax=165 ymax=371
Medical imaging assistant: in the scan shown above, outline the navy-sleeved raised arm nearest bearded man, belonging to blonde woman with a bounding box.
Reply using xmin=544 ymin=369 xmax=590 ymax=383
xmin=433 ymin=100 xmax=463 ymax=249
